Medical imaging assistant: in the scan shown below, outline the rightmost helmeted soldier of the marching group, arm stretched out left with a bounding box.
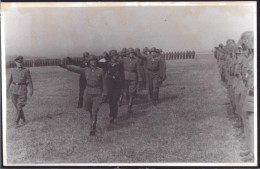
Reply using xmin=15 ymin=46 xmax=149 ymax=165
xmin=137 ymin=47 xmax=164 ymax=105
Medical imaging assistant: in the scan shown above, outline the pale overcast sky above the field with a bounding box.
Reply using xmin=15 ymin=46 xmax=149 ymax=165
xmin=2 ymin=3 xmax=256 ymax=60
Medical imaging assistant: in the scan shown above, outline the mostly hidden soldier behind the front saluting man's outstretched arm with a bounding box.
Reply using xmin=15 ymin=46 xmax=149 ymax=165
xmin=67 ymin=52 xmax=89 ymax=108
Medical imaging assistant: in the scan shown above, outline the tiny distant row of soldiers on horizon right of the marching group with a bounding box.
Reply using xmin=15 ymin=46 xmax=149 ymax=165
xmin=165 ymin=50 xmax=195 ymax=60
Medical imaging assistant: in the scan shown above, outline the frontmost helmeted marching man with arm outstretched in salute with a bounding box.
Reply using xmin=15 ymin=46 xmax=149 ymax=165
xmin=60 ymin=55 xmax=107 ymax=136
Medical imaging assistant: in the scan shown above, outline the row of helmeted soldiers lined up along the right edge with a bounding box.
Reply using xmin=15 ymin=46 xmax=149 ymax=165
xmin=214 ymin=31 xmax=254 ymax=160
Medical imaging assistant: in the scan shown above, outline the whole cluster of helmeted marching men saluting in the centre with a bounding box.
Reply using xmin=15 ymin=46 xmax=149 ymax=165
xmin=59 ymin=47 xmax=166 ymax=136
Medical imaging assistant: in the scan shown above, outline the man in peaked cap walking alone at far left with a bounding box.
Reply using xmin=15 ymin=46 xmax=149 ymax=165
xmin=7 ymin=56 xmax=33 ymax=127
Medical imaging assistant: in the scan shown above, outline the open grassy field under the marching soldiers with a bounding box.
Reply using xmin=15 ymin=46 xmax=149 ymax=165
xmin=6 ymin=55 xmax=245 ymax=164
